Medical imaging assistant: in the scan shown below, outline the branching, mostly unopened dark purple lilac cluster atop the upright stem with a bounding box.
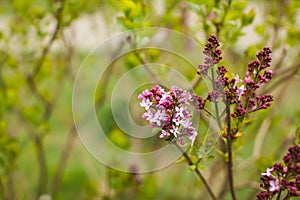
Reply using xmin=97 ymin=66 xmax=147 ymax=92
xmin=197 ymin=35 xmax=273 ymax=134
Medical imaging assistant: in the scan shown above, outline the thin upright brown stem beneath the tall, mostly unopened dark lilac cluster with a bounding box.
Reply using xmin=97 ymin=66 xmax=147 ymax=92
xmin=226 ymin=102 xmax=236 ymax=200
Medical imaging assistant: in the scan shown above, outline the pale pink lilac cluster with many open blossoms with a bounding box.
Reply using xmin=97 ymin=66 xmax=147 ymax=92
xmin=138 ymin=85 xmax=198 ymax=145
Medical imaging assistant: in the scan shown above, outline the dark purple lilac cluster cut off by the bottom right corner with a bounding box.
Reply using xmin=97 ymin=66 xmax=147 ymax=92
xmin=257 ymin=145 xmax=300 ymax=200
